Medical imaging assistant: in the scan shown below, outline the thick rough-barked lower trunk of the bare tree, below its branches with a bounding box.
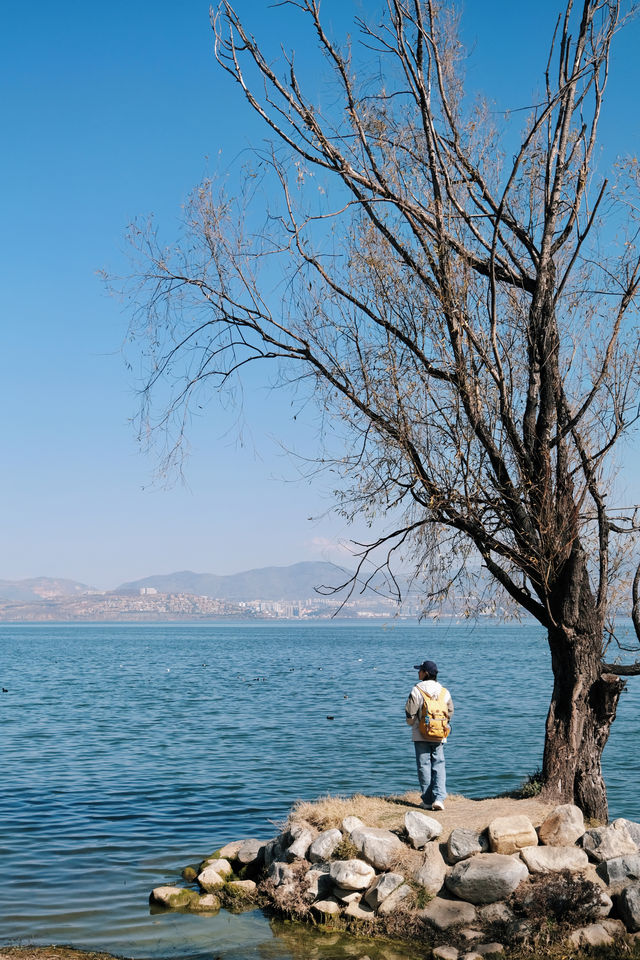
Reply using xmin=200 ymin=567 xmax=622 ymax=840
xmin=542 ymin=623 xmax=625 ymax=823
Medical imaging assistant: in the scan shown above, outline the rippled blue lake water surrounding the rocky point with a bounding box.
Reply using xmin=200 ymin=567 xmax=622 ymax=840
xmin=0 ymin=621 xmax=640 ymax=960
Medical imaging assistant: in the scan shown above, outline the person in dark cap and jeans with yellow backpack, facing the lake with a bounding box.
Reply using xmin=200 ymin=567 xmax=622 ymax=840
xmin=404 ymin=660 xmax=453 ymax=810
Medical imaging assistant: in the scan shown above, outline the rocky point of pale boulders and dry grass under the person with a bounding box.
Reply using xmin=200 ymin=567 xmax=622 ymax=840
xmin=150 ymin=797 xmax=640 ymax=960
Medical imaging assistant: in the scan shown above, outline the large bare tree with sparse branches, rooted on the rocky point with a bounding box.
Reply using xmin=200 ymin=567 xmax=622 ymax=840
xmin=124 ymin=0 xmax=640 ymax=819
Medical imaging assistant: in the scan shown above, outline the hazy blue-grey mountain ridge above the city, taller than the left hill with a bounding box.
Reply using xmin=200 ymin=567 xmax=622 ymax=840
xmin=113 ymin=561 xmax=351 ymax=602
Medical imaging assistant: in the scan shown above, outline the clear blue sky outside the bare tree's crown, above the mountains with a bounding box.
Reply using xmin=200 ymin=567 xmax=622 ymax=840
xmin=0 ymin=0 xmax=639 ymax=588
